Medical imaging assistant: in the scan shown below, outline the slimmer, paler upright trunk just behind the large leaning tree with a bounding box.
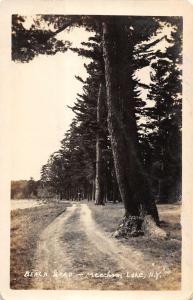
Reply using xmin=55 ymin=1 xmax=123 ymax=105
xmin=95 ymin=83 xmax=104 ymax=205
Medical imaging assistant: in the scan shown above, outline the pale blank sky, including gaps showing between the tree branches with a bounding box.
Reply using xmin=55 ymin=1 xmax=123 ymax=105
xmin=11 ymin=21 xmax=172 ymax=180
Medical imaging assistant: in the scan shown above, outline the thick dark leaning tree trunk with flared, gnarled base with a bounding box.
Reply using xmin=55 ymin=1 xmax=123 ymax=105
xmin=103 ymin=17 xmax=164 ymax=236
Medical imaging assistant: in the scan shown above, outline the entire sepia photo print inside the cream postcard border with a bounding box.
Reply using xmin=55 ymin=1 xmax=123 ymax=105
xmin=10 ymin=13 xmax=183 ymax=291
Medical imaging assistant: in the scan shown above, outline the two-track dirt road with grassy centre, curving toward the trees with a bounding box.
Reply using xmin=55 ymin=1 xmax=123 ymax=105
xmin=31 ymin=203 xmax=172 ymax=290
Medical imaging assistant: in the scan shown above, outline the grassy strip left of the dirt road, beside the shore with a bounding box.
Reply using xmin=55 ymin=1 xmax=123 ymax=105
xmin=10 ymin=202 xmax=70 ymax=289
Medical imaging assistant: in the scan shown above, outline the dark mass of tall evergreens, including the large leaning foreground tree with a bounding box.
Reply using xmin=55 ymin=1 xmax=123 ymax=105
xmin=12 ymin=15 xmax=182 ymax=235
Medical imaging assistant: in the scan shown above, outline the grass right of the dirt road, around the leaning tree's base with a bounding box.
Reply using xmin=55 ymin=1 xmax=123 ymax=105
xmin=90 ymin=204 xmax=181 ymax=290
